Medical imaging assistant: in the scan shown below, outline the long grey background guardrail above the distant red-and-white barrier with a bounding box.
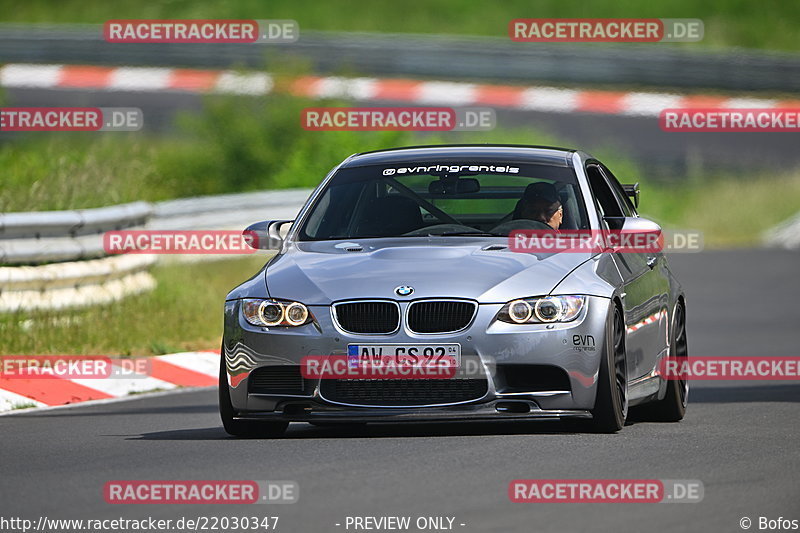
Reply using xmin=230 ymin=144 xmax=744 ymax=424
xmin=0 ymin=24 xmax=800 ymax=92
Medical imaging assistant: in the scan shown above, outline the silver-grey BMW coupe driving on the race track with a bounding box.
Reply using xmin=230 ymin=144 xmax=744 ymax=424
xmin=219 ymin=145 xmax=688 ymax=436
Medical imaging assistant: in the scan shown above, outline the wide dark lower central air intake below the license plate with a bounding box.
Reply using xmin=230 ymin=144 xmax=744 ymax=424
xmin=321 ymin=379 xmax=489 ymax=407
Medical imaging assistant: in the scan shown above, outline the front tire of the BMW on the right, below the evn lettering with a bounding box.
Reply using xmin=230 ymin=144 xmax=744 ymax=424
xmin=592 ymin=305 xmax=628 ymax=433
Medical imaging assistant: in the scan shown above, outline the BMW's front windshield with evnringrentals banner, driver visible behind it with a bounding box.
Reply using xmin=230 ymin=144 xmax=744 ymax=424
xmin=299 ymin=162 xmax=589 ymax=240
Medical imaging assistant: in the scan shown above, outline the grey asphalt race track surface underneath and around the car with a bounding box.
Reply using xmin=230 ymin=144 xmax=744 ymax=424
xmin=0 ymin=251 xmax=800 ymax=532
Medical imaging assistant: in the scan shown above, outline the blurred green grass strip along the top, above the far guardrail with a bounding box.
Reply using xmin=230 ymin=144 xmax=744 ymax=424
xmin=0 ymin=0 xmax=800 ymax=50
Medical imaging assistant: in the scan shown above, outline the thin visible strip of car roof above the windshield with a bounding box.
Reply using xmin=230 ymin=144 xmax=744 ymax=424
xmin=342 ymin=144 xmax=575 ymax=168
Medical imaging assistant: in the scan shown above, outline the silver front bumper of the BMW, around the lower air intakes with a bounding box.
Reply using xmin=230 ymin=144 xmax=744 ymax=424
xmin=223 ymin=296 xmax=610 ymax=422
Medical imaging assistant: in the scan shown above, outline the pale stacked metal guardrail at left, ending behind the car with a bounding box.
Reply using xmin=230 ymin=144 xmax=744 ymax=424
xmin=0 ymin=189 xmax=310 ymax=312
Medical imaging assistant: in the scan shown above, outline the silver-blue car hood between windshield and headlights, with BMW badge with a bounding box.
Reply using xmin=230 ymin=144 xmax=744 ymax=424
xmin=265 ymin=237 xmax=591 ymax=305
